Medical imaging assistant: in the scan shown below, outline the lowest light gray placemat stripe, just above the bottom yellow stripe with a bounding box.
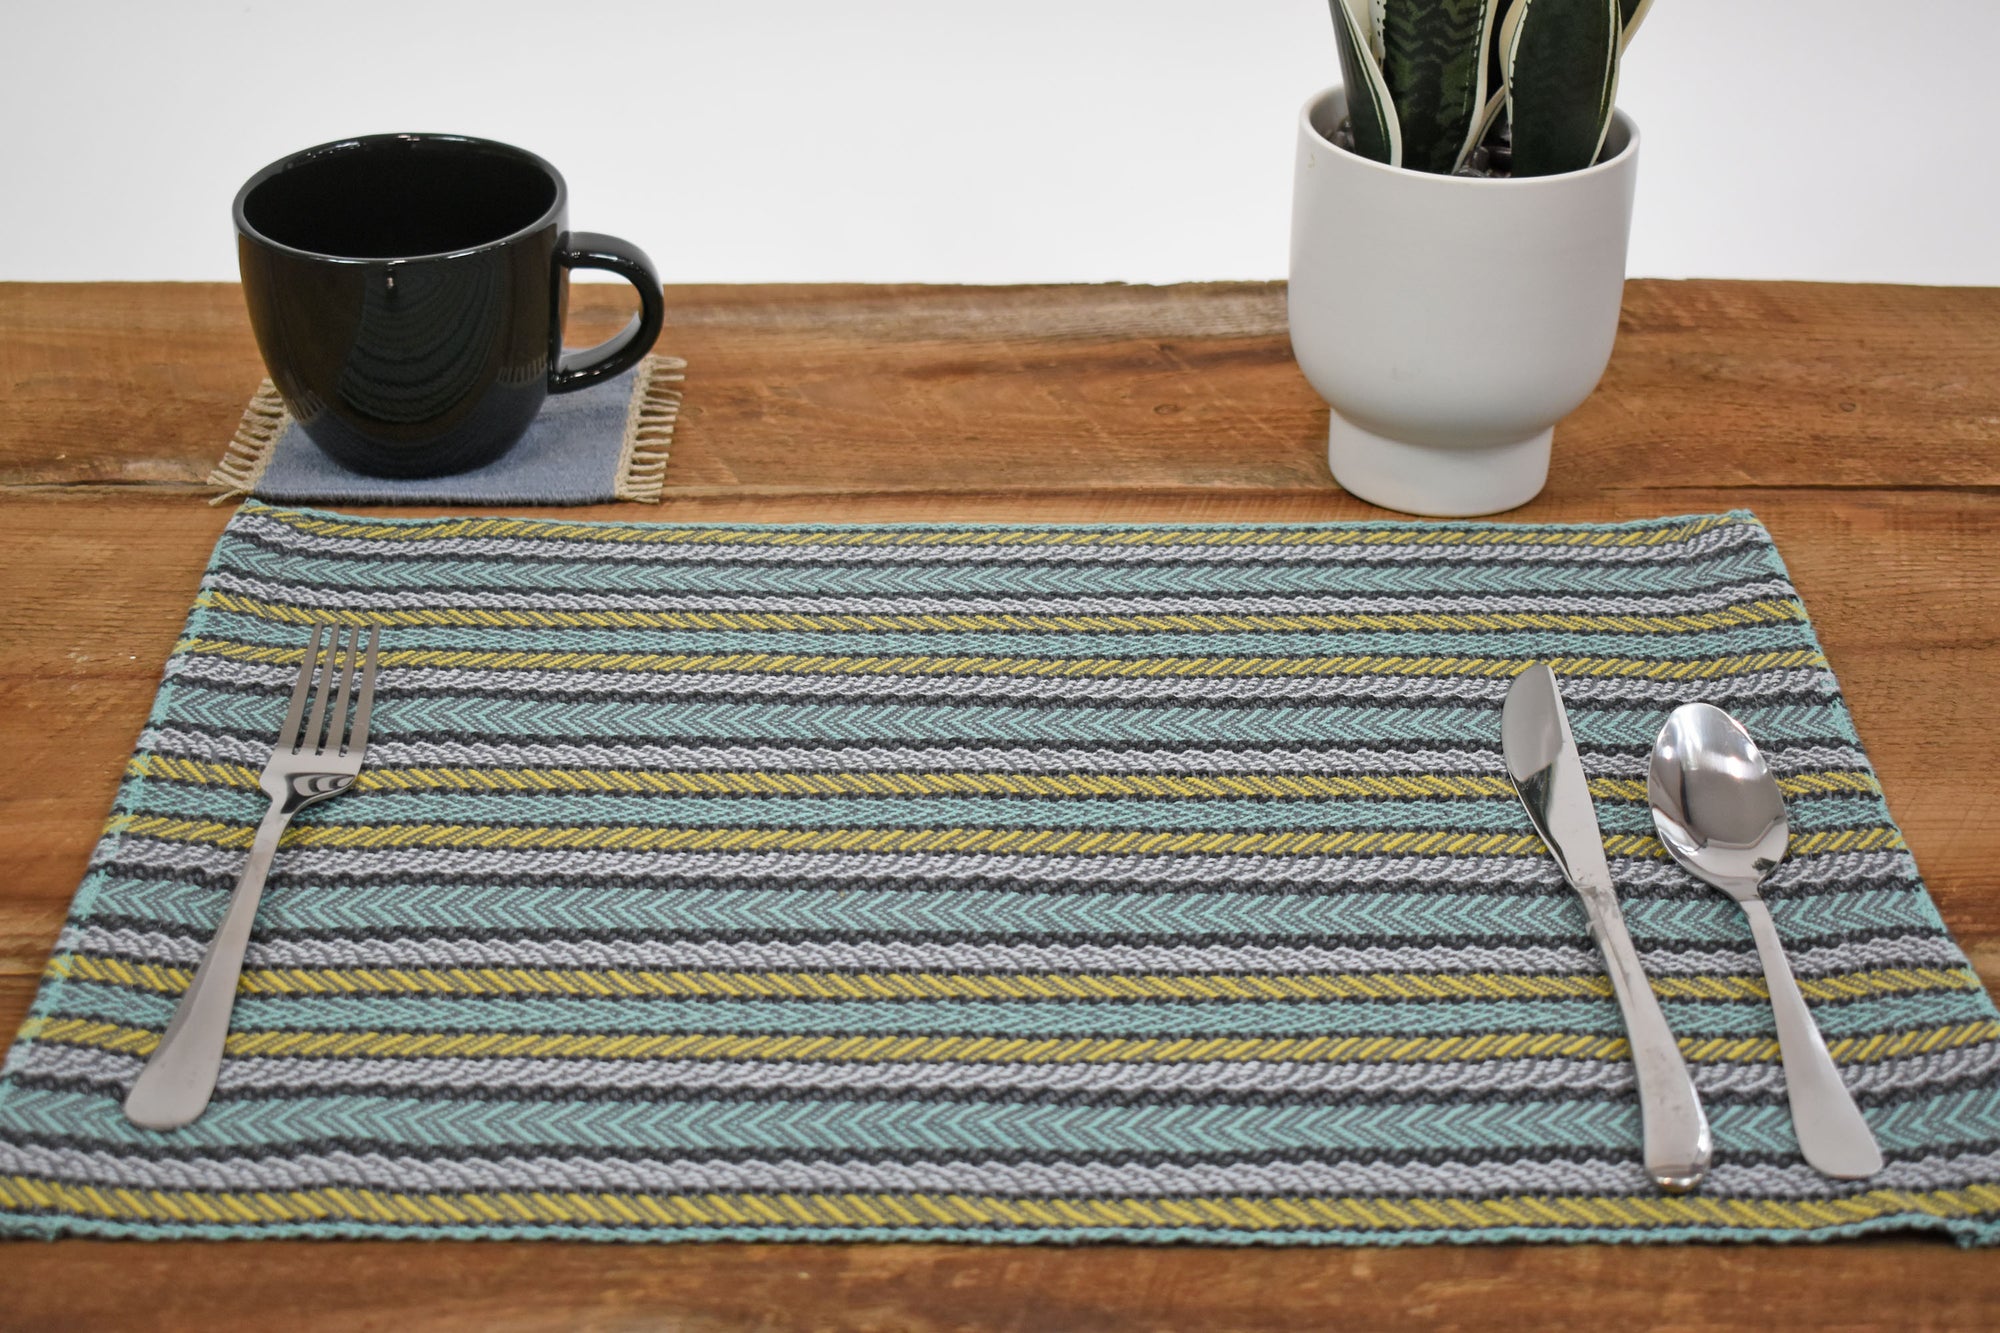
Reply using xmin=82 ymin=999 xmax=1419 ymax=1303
xmin=0 ymin=1145 xmax=2000 ymax=1199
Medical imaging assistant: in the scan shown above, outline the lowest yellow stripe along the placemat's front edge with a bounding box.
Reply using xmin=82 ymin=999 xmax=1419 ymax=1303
xmin=0 ymin=1175 xmax=2000 ymax=1231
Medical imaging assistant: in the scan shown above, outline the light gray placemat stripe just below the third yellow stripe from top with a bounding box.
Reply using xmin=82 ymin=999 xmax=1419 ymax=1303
xmin=170 ymin=656 xmax=1838 ymax=709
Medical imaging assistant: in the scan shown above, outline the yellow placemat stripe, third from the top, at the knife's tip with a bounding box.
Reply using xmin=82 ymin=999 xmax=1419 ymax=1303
xmin=174 ymin=636 xmax=1828 ymax=681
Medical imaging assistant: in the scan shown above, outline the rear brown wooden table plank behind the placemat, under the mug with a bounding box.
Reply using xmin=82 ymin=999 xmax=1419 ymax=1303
xmin=11 ymin=282 xmax=2000 ymax=492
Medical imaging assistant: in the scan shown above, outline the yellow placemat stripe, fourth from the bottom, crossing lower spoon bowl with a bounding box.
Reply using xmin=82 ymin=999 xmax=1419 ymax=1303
xmin=104 ymin=815 xmax=1904 ymax=859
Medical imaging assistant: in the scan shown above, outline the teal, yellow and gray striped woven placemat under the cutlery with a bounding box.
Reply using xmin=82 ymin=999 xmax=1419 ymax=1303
xmin=0 ymin=502 xmax=2000 ymax=1243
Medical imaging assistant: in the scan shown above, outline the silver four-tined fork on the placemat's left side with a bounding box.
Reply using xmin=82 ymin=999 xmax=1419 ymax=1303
xmin=124 ymin=624 xmax=382 ymax=1129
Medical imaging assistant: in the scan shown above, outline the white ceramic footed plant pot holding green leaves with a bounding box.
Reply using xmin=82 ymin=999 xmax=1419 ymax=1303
xmin=1288 ymin=88 xmax=1638 ymax=516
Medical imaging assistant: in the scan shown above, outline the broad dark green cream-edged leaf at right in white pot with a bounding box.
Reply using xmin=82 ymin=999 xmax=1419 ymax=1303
xmin=1502 ymin=0 xmax=1624 ymax=176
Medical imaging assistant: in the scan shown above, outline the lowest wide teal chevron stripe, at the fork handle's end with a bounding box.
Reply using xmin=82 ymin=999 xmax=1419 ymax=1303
xmin=10 ymin=1091 xmax=2000 ymax=1159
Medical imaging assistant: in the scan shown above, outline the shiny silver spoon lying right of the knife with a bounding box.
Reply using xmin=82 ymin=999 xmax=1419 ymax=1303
xmin=1646 ymin=703 xmax=1882 ymax=1181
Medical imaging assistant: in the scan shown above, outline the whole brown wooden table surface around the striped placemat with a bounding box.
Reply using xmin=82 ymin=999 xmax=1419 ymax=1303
xmin=0 ymin=282 xmax=2000 ymax=1333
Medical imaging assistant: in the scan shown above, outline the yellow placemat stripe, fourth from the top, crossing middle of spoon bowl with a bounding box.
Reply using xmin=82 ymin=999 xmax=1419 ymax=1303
xmin=126 ymin=755 xmax=1882 ymax=803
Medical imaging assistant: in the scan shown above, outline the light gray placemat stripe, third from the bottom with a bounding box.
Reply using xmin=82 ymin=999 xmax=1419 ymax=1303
xmin=56 ymin=925 xmax=1966 ymax=977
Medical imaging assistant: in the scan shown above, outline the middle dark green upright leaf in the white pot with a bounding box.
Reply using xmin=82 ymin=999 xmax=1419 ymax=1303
xmin=1382 ymin=0 xmax=1496 ymax=172
